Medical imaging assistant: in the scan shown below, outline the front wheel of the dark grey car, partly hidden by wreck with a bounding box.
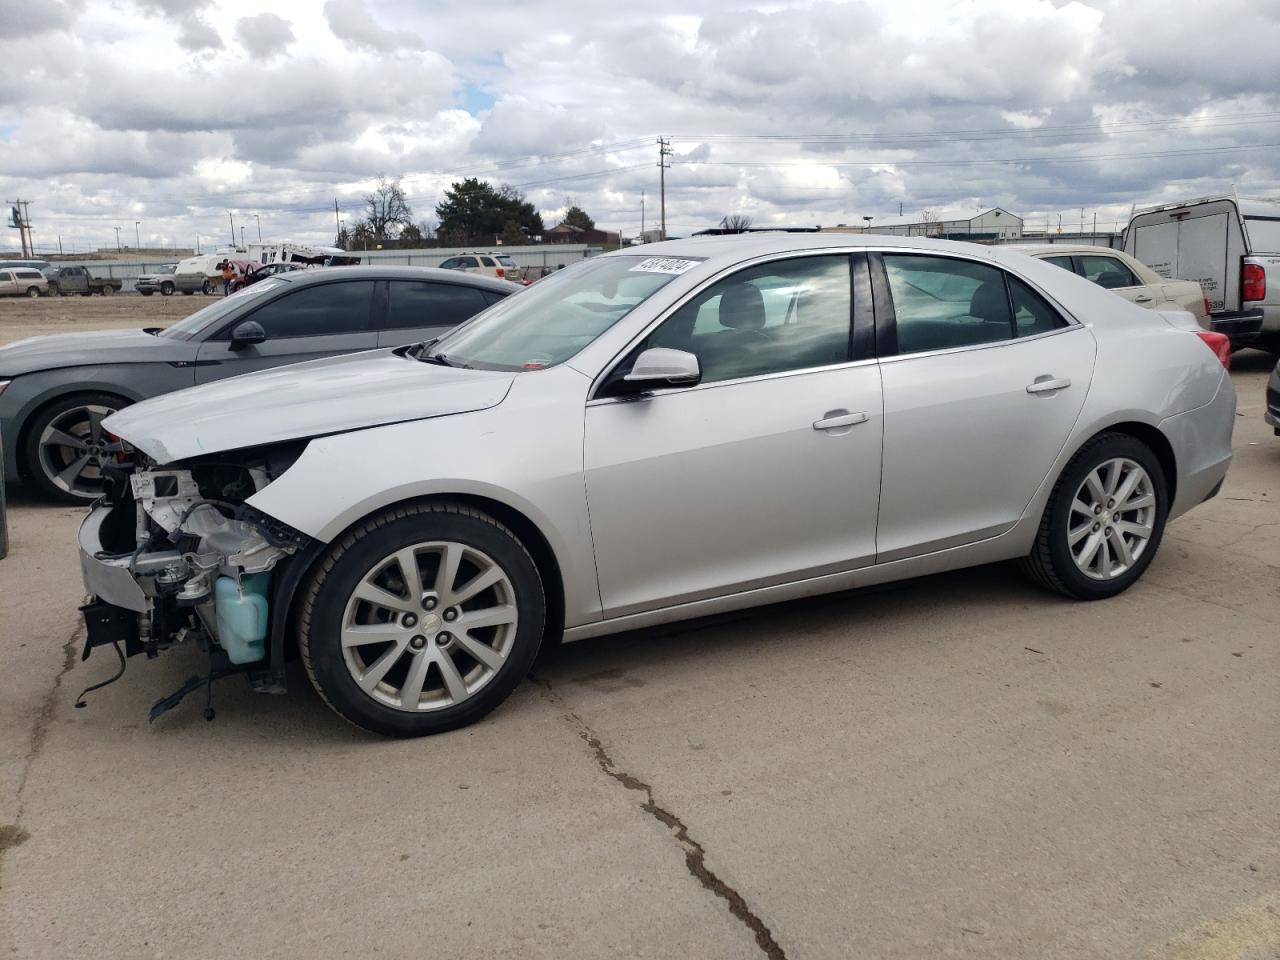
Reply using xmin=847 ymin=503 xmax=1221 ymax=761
xmin=24 ymin=393 xmax=125 ymax=503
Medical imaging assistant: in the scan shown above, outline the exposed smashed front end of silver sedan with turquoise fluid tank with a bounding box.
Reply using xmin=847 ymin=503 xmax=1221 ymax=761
xmin=77 ymin=442 xmax=316 ymax=719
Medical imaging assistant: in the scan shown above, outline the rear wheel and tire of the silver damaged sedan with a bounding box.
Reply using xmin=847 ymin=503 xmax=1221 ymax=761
xmin=1021 ymin=434 xmax=1169 ymax=600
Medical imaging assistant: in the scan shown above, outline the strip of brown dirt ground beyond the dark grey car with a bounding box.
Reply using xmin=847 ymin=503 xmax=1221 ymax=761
xmin=0 ymin=293 xmax=218 ymax=344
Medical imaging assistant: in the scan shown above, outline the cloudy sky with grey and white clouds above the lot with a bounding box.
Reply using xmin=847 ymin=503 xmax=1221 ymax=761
xmin=0 ymin=0 xmax=1280 ymax=251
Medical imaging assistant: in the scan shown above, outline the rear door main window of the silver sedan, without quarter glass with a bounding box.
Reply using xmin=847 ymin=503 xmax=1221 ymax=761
xmin=884 ymin=253 xmax=1014 ymax=353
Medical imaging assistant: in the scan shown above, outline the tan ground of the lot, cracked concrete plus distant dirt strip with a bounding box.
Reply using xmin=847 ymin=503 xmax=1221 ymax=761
xmin=0 ymin=297 xmax=1280 ymax=960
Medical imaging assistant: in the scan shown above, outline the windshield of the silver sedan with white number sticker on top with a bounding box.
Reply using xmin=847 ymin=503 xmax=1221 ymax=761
xmin=431 ymin=256 xmax=696 ymax=370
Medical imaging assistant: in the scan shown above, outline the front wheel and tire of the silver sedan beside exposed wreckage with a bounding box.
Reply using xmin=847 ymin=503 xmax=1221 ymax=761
xmin=298 ymin=502 xmax=545 ymax=737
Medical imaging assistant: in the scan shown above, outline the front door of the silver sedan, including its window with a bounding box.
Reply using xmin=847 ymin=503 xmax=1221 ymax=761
xmin=585 ymin=255 xmax=882 ymax=616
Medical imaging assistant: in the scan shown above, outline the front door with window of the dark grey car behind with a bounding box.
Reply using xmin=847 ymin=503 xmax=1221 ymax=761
xmin=196 ymin=280 xmax=378 ymax=383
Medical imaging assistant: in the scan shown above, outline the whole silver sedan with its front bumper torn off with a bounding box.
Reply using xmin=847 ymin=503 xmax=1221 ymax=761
xmin=81 ymin=234 xmax=1235 ymax=736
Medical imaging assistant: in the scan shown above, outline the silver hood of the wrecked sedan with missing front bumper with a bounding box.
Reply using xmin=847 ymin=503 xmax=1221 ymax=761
xmin=102 ymin=351 xmax=516 ymax=463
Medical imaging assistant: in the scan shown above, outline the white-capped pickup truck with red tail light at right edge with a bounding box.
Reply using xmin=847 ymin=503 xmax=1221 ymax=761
xmin=1124 ymin=196 xmax=1280 ymax=353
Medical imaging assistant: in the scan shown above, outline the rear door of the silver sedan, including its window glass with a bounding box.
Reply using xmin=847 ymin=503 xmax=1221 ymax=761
xmin=872 ymin=252 xmax=1096 ymax=562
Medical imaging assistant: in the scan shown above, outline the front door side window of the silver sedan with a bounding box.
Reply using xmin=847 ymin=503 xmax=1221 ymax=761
xmin=637 ymin=256 xmax=852 ymax=383
